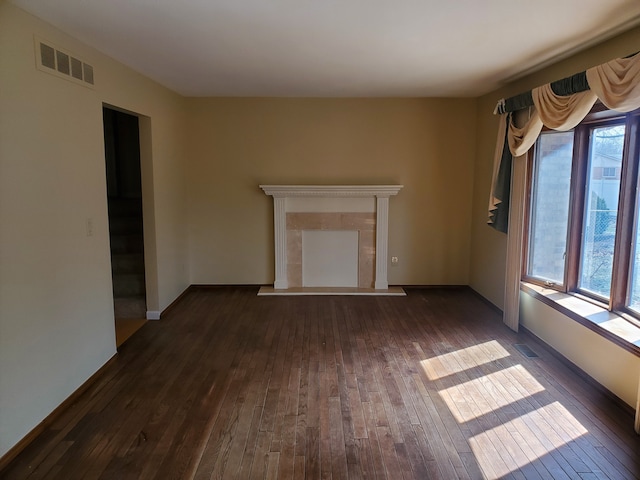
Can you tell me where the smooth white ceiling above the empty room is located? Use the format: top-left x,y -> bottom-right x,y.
12,0 -> 640,97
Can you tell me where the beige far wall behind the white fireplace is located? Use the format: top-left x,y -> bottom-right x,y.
188,98 -> 475,285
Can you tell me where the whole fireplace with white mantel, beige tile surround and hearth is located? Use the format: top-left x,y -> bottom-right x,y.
259,185 -> 404,295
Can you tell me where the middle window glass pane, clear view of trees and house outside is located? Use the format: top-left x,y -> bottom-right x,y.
579,125 -> 624,298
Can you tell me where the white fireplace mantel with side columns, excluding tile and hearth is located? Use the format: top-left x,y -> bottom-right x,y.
260,185 -> 403,290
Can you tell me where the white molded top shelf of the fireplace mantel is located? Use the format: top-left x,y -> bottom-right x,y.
260,185 -> 403,197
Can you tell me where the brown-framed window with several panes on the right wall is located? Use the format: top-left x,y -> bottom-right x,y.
523,106 -> 640,324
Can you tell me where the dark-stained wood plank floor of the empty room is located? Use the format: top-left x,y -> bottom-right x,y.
0,287 -> 640,480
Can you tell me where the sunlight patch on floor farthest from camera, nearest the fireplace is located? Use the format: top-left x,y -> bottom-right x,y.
420,340 -> 510,380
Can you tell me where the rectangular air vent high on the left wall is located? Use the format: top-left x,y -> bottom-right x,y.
35,37 -> 94,87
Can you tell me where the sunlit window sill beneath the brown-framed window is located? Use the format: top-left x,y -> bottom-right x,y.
520,282 -> 640,357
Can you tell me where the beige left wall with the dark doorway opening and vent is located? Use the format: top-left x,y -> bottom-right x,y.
0,2 -> 188,462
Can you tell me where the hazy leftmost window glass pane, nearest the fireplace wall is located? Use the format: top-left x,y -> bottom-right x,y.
527,132 -> 573,284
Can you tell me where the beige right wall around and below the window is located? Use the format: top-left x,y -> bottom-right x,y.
470,29 -> 640,406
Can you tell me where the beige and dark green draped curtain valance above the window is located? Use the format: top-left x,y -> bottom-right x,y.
488,54 -> 640,233
